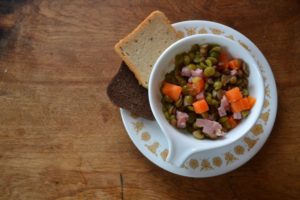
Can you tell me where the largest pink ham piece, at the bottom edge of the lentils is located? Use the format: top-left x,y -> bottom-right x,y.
195,119 -> 224,138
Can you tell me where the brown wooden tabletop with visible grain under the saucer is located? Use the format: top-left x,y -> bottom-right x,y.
0,0 -> 300,200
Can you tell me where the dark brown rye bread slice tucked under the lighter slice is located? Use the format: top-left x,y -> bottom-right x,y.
106,62 -> 154,120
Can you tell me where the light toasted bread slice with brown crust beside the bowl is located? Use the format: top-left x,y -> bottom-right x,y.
115,11 -> 178,88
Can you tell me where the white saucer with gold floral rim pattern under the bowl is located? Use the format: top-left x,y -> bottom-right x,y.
120,20 -> 277,177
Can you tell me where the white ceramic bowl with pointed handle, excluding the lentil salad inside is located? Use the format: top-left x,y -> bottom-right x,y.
148,34 -> 264,166
